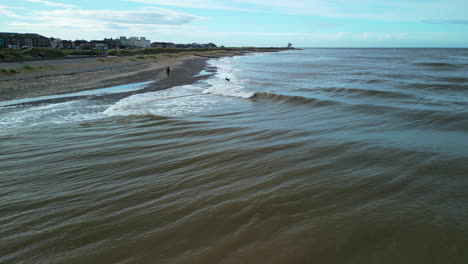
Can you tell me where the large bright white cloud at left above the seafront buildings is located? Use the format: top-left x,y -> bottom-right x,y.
8,8 -> 206,39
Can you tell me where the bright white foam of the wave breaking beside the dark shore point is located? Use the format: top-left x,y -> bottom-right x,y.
104,54 -> 255,117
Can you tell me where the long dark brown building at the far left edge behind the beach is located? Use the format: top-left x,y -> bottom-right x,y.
0,32 -> 51,48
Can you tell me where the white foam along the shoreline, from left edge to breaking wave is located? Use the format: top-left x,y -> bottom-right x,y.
0,58 -> 254,132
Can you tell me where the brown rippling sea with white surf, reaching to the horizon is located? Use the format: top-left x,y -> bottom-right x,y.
0,48 -> 468,264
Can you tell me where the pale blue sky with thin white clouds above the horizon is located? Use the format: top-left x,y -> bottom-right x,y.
0,0 -> 468,48
